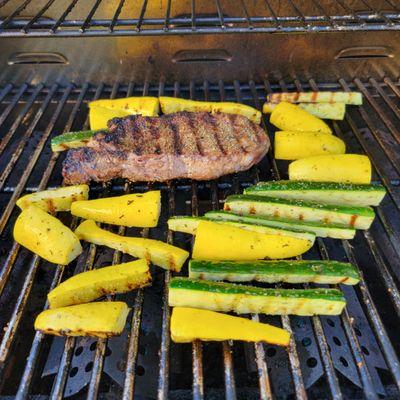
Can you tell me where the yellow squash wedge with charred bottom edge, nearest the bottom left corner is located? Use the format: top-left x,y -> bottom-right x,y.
35,301 -> 129,338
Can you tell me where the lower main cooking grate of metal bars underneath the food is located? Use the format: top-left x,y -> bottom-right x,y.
0,78 -> 400,399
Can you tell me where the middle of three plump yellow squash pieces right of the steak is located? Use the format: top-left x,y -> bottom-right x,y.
275,131 -> 346,160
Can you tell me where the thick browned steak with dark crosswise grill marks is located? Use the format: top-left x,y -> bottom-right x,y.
63,112 -> 269,184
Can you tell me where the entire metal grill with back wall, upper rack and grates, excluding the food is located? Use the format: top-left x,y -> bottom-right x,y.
0,0 -> 400,400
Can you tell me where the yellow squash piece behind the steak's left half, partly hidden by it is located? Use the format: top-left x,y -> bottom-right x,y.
89,97 -> 159,129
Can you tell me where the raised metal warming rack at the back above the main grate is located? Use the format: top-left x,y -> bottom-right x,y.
0,0 -> 400,37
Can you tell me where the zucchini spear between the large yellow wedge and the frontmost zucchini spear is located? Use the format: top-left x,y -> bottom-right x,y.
189,260 -> 360,285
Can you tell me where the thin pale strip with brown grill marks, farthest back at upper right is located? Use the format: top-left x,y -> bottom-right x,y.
267,92 -> 362,106
